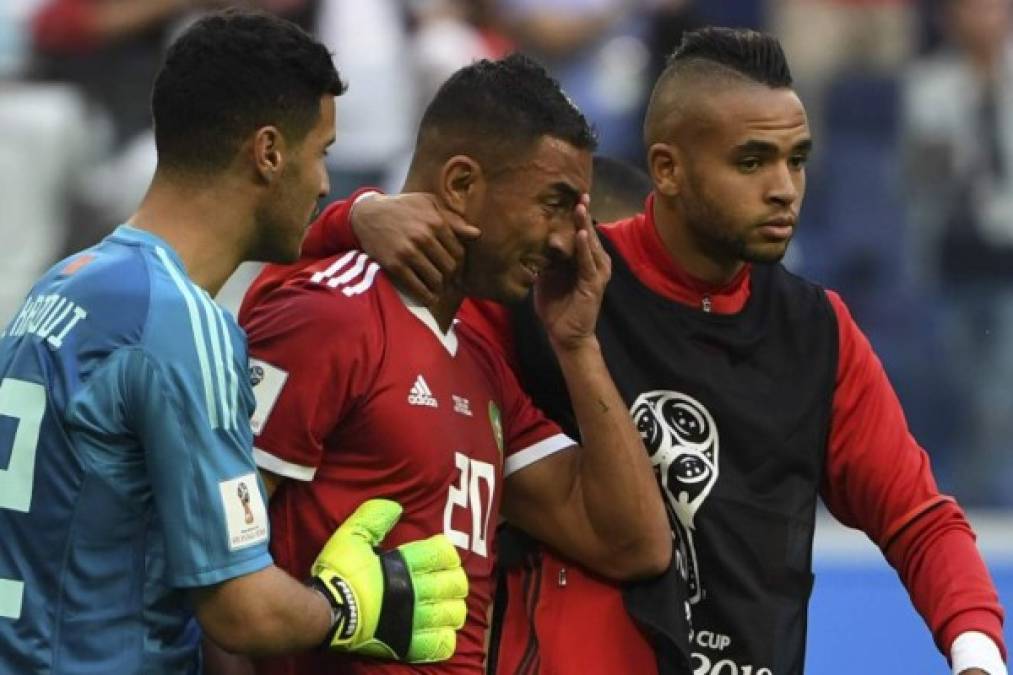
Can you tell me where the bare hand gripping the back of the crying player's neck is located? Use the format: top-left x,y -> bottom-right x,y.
350,193 -> 481,305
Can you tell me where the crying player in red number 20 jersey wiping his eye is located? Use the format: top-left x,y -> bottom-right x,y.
240,56 -> 672,675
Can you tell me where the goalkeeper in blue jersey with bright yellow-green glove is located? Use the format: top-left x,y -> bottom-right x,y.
0,11 -> 467,675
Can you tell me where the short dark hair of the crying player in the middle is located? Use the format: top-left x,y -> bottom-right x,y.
416,54 -> 598,167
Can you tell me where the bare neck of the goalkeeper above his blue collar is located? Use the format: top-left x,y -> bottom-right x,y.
130,168 -> 254,296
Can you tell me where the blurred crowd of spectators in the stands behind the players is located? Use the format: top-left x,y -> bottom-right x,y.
0,0 -> 1013,507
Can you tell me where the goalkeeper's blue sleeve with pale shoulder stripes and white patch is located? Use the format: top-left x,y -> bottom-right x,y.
127,255 -> 270,587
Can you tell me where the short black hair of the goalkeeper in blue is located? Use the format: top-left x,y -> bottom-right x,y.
151,9 -> 344,171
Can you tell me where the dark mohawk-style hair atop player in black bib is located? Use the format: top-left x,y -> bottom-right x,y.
666,26 -> 791,88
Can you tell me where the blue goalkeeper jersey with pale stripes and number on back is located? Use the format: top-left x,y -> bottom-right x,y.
0,225 -> 271,675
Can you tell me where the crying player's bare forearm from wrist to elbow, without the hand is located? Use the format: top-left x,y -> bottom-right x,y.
554,339 -> 672,571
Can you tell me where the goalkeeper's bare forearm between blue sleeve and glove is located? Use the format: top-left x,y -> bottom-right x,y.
196,567 -> 332,655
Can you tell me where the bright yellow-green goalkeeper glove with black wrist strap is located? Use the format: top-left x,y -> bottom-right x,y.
310,500 -> 468,663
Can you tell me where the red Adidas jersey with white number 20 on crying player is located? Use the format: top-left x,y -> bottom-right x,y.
243,251 -> 573,675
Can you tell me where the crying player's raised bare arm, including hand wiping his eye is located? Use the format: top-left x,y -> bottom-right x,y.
502,198 -> 672,579
